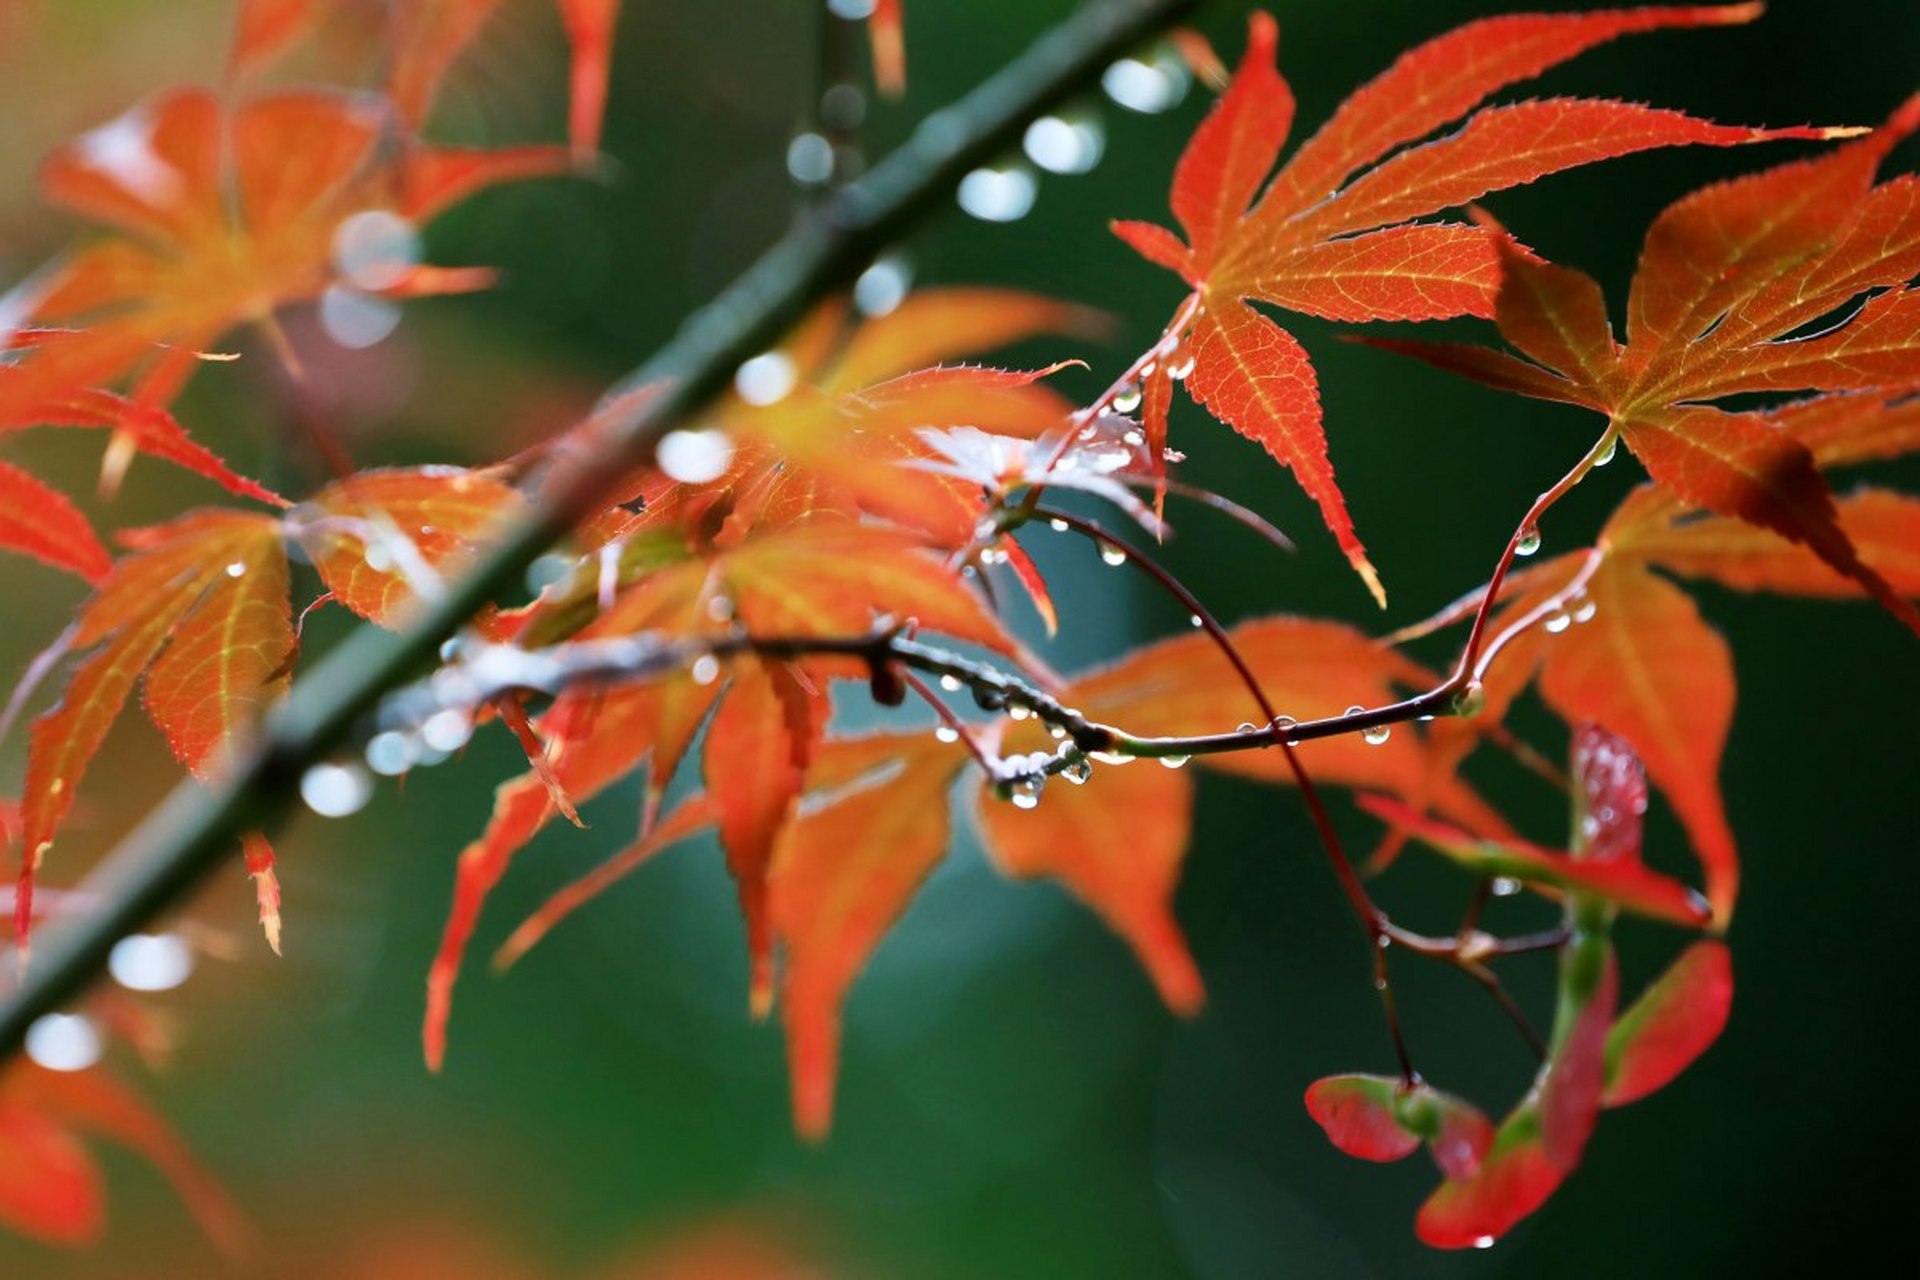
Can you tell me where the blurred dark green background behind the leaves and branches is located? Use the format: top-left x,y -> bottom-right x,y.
0,0 -> 1920,1280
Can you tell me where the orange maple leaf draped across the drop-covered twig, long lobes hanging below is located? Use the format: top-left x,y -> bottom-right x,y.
422,518 -> 1023,1067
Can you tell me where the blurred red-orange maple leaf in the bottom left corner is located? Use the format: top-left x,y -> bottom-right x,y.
0,1061 -> 248,1253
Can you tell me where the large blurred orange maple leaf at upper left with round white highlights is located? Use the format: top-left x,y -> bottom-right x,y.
11,88 -> 563,475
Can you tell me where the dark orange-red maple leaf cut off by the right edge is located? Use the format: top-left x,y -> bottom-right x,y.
1388,98 -> 1920,631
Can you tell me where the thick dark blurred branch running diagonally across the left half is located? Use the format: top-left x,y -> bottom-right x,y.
0,0 -> 1198,1061
